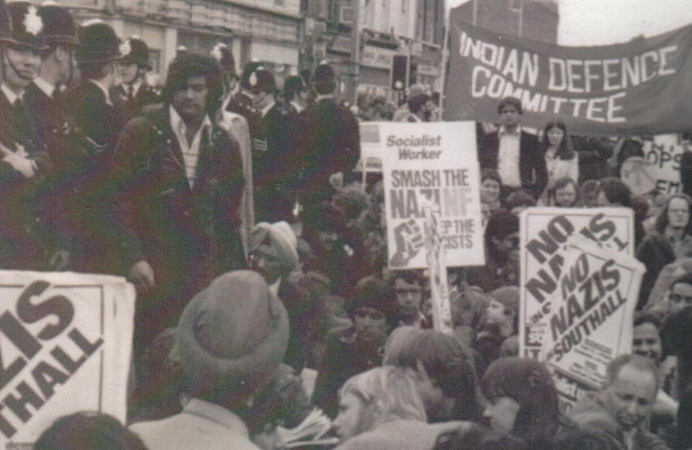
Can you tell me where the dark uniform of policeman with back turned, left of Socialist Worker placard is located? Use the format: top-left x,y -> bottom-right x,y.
301,99 -> 360,196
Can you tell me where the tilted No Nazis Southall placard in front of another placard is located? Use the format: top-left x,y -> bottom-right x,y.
539,238 -> 646,411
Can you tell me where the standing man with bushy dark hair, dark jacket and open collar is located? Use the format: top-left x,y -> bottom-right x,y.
113,52 -> 245,358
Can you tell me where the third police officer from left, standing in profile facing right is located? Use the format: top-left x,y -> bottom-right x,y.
62,20 -> 125,274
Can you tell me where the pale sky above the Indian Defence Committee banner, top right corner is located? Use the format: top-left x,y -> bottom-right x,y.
447,0 -> 692,46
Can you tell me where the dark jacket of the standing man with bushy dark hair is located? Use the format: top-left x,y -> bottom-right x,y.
112,107 -> 245,337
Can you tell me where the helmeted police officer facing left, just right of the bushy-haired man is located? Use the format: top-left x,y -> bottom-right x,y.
248,66 -> 300,222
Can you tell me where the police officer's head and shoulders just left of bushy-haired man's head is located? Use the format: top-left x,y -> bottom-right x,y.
111,36 -> 161,120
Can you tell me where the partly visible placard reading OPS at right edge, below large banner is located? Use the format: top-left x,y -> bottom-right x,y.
644,134 -> 692,194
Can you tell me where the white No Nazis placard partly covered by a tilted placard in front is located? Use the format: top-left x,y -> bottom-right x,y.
519,208 -> 636,358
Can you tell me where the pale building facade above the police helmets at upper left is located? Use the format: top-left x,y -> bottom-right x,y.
65,0 -> 304,85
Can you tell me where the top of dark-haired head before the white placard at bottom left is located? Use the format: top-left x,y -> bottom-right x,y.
33,412 -> 150,450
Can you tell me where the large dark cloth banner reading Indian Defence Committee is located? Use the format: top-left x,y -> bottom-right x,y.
444,8 -> 692,135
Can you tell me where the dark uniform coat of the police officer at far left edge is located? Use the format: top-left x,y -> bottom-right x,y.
0,89 -> 51,270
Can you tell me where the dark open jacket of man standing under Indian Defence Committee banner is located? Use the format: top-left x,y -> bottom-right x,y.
478,131 -> 548,198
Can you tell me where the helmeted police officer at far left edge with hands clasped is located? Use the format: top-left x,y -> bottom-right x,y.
0,2 -> 50,270
